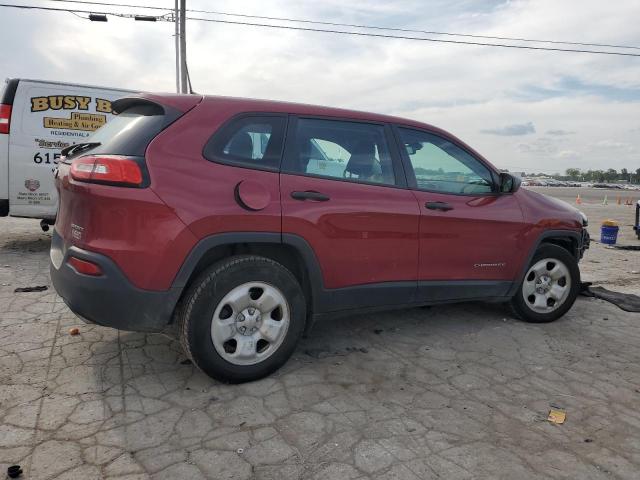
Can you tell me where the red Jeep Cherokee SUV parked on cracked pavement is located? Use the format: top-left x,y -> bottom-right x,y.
51,95 -> 588,382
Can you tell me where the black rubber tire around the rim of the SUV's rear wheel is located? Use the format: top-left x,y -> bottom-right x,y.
176,255 -> 306,383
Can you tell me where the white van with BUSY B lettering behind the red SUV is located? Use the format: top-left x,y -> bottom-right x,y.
0,78 -> 132,230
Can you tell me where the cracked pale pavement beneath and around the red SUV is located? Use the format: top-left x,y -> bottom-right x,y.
0,189 -> 640,480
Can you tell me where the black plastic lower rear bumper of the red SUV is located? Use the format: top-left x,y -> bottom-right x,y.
50,229 -> 182,332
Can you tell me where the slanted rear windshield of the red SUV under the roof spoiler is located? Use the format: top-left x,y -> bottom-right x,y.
68,103 -> 181,158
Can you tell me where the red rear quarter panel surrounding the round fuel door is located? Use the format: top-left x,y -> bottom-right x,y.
145,99 -> 281,239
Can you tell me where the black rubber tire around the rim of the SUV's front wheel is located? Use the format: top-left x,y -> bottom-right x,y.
509,244 -> 580,323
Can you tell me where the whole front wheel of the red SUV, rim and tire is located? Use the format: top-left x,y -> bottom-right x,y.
510,244 -> 580,323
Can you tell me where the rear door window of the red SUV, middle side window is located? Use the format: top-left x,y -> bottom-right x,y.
288,118 -> 395,185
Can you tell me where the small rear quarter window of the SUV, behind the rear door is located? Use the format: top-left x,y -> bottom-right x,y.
203,115 -> 286,170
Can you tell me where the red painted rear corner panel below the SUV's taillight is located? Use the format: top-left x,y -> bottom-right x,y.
55,164 -> 197,290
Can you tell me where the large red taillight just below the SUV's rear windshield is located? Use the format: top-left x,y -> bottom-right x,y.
70,155 -> 144,187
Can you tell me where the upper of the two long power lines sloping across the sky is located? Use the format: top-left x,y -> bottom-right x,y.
47,0 -> 640,50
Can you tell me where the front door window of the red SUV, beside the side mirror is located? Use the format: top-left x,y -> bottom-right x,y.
399,128 -> 493,195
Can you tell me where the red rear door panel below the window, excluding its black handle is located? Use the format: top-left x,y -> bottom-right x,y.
281,174 -> 420,288
